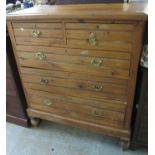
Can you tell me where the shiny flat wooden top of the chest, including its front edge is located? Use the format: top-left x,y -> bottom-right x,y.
7,3 -> 147,21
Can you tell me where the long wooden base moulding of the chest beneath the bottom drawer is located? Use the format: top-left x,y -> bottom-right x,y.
27,108 -> 130,139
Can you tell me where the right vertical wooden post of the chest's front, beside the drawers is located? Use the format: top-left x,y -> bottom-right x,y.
124,23 -> 144,128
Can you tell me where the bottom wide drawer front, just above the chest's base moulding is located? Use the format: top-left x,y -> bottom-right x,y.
29,90 -> 124,127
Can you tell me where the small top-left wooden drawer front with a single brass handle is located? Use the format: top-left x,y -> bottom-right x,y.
13,23 -> 64,45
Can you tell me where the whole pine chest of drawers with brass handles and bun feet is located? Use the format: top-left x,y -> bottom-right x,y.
7,3 -> 147,147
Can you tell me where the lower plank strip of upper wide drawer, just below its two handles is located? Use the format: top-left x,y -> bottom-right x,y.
19,59 -> 129,79
